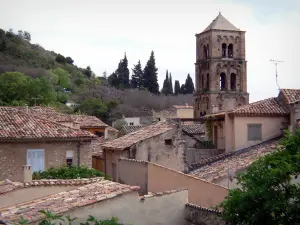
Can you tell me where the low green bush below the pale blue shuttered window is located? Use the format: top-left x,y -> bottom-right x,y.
32,166 -> 104,180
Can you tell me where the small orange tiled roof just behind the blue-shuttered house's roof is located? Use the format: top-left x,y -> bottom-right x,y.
72,115 -> 108,128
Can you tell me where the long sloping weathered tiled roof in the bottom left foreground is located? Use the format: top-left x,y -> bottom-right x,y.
0,180 -> 139,223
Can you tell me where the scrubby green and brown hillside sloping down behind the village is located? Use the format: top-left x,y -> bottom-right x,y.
0,29 -> 193,123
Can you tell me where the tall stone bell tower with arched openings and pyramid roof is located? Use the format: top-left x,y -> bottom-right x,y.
194,13 -> 249,118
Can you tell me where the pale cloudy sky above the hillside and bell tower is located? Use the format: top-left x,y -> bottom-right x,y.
0,0 -> 300,102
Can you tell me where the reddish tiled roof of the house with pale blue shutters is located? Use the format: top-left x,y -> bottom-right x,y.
0,107 -> 95,141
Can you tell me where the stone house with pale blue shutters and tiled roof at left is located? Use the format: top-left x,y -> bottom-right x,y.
0,107 -> 95,180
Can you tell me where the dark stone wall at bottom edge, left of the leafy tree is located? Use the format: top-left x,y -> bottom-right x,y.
184,203 -> 225,225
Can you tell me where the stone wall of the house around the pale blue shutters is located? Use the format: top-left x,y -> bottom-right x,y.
0,142 -> 92,181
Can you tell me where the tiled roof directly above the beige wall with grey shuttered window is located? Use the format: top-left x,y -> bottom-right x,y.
230,98 -> 289,116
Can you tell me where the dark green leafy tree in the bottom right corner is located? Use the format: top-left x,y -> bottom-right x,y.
219,129 -> 300,225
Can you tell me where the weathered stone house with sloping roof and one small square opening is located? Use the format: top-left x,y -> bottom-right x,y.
102,122 -> 187,181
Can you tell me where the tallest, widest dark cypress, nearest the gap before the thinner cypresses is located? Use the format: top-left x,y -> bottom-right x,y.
143,51 -> 159,94
